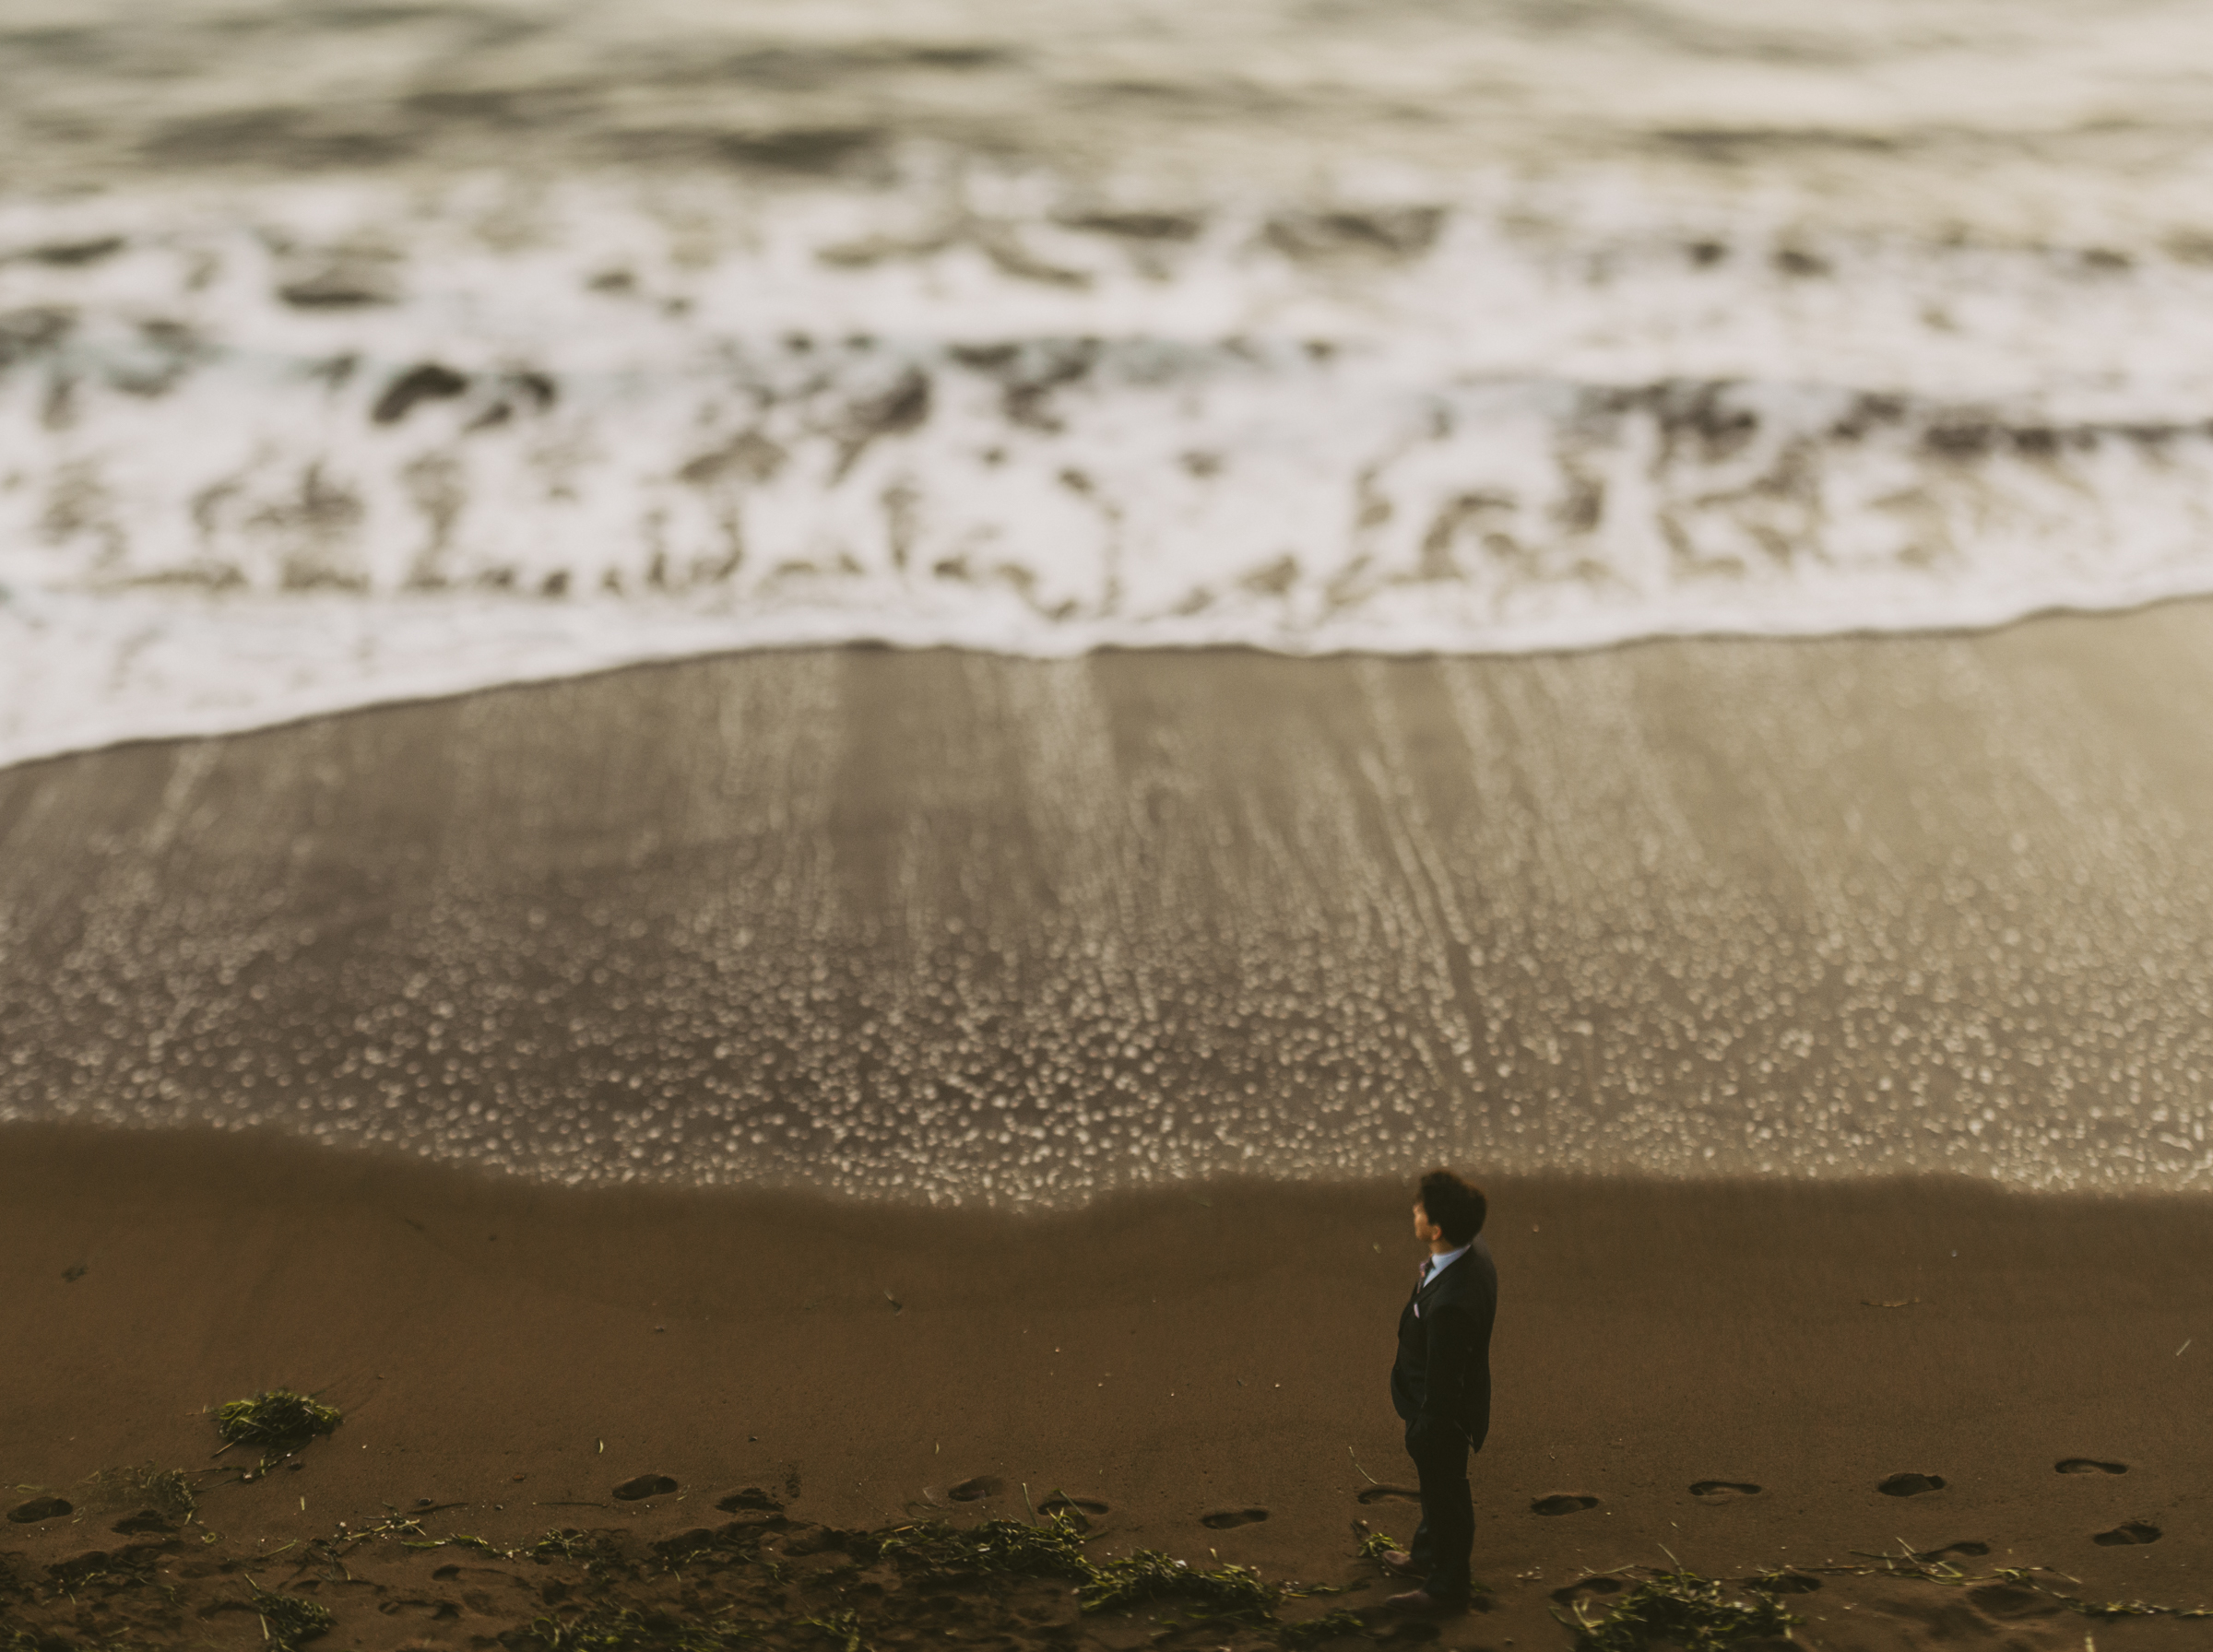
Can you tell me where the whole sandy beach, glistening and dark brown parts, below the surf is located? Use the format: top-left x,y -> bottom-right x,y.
13,606 -> 2213,1652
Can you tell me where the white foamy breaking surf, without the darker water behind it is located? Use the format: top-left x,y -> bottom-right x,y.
0,164 -> 2213,761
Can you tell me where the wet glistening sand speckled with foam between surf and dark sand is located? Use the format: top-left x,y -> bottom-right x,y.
0,604 -> 2213,1203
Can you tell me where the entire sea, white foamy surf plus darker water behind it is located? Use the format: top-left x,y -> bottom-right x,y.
0,0 -> 2213,761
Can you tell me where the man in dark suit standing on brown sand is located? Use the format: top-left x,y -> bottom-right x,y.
1383,1170 -> 1498,1612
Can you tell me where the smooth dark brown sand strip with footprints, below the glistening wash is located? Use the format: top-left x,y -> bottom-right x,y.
0,1126 -> 2213,1647
